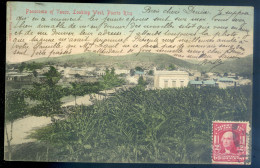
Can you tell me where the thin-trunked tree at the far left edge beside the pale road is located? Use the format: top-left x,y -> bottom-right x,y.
5,90 -> 28,161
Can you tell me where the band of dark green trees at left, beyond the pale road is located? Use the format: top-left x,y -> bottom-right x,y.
5,66 -> 124,160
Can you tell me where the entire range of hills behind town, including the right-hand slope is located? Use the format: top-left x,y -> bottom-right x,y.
24,52 -> 253,75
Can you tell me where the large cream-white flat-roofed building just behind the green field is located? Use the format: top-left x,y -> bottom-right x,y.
154,68 -> 189,89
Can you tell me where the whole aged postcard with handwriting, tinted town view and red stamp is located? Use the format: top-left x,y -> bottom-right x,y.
5,2 -> 254,164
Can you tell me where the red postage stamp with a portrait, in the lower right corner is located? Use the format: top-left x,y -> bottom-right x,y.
212,121 -> 250,164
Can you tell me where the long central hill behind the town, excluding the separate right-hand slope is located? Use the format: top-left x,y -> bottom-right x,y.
28,52 -> 198,69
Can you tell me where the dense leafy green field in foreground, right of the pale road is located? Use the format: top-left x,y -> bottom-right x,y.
29,87 -> 251,163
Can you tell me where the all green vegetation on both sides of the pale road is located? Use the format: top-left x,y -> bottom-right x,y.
6,62 -> 252,163
